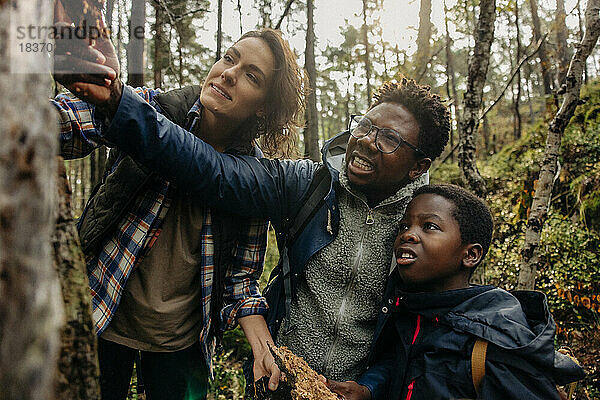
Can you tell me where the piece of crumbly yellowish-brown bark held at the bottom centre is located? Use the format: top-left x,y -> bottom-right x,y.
269,346 -> 340,400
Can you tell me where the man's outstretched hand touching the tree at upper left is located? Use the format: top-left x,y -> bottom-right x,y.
54,0 -> 123,117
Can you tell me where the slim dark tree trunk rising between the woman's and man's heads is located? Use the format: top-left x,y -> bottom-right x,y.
304,0 -> 320,162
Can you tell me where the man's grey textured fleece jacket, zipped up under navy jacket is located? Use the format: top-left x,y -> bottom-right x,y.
277,163 -> 428,381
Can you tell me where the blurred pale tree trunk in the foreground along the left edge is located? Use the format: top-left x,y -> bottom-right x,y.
0,0 -> 63,400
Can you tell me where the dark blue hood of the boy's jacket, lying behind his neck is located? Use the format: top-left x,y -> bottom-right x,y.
403,286 -> 585,384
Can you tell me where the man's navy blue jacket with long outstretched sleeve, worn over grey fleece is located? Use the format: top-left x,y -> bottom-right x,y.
99,83 -> 382,390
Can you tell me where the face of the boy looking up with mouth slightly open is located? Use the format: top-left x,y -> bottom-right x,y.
394,193 -> 481,292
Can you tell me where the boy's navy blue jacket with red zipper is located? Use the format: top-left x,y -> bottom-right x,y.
363,271 -> 584,400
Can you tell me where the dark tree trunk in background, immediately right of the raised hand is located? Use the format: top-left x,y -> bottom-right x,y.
127,0 -> 146,87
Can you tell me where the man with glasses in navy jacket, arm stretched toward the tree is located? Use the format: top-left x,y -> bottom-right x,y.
76,78 -> 450,399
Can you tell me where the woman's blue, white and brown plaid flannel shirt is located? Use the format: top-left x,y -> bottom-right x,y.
51,88 -> 268,371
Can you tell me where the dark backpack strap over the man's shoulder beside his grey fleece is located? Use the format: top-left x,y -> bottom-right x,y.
281,165 -> 331,334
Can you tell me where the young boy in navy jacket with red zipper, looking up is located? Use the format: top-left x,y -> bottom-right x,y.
354,185 -> 584,400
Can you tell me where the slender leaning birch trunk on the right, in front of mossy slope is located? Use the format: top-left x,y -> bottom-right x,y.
517,0 -> 600,289
